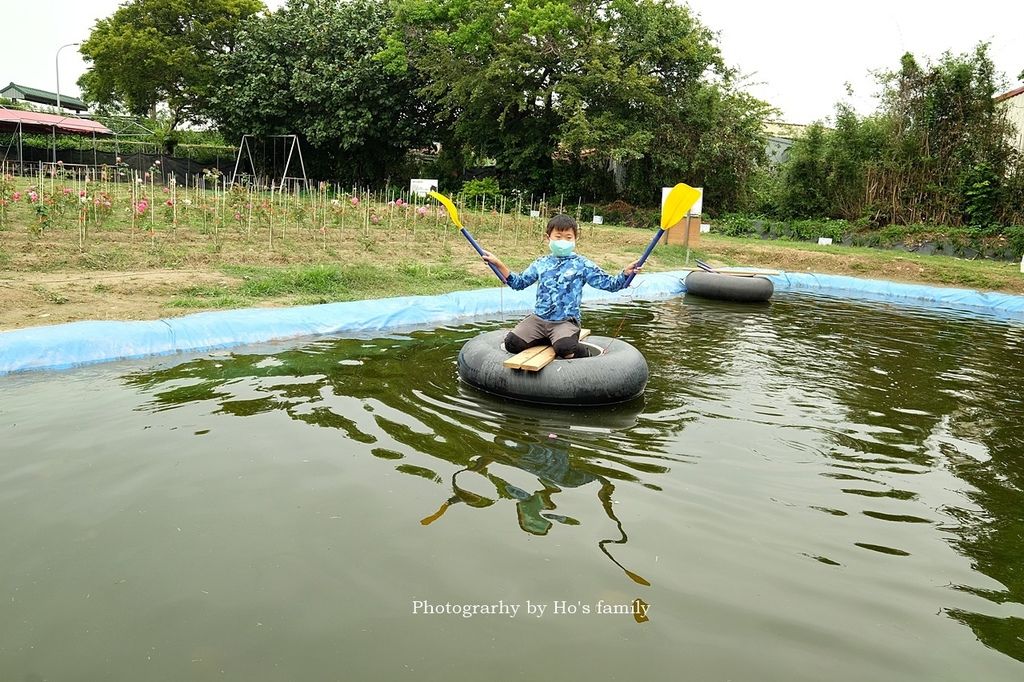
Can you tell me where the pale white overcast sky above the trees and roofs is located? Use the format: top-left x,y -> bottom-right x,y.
0,0 -> 1024,124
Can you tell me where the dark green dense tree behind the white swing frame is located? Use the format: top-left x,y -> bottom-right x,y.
209,0 -> 429,181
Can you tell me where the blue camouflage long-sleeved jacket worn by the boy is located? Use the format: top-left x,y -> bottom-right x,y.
508,254 -> 626,324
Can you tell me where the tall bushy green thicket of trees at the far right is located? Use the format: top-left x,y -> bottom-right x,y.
779,44 -> 1024,229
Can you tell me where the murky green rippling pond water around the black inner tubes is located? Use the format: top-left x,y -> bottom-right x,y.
0,296 -> 1024,682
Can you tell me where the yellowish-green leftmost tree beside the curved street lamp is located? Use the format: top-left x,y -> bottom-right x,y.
78,0 -> 265,131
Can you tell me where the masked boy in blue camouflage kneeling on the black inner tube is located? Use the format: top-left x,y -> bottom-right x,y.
483,215 -> 640,358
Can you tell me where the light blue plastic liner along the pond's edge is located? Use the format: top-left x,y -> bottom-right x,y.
0,270 -> 1024,375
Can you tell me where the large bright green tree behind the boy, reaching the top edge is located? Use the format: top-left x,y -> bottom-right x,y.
389,0 -> 768,203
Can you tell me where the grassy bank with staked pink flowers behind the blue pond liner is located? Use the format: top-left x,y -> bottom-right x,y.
0,169 -> 1024,329
